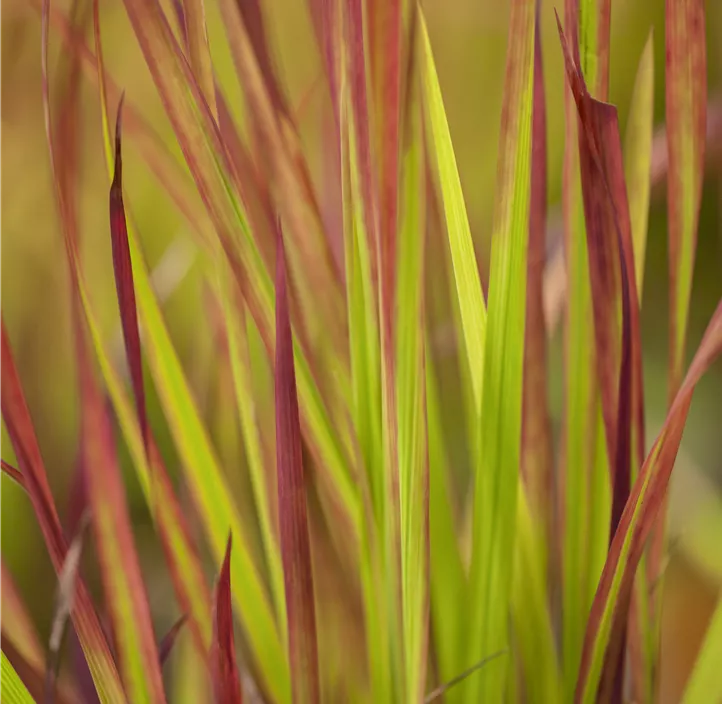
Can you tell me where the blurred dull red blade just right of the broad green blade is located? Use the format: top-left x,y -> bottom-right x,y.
521,3 -> 554,548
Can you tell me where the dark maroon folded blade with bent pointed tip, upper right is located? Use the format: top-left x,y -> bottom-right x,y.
557,12 -> 644,699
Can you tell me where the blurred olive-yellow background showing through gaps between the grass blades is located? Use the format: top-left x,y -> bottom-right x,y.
0,0 -> 722,702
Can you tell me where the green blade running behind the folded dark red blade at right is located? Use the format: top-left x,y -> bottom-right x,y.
561,0 -> 611,701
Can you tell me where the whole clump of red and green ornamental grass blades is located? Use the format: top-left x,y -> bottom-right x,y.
0,0 -> 722,704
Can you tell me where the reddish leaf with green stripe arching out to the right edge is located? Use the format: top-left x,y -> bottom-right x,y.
575,301 -> 722,704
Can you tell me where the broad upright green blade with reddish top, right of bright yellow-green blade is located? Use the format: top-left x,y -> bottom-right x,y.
462,0 -> 536,701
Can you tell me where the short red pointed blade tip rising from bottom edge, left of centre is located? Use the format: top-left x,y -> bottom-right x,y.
210,535 -> 243,704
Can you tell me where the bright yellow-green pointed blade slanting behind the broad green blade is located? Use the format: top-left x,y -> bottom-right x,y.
419,11 -> 486,412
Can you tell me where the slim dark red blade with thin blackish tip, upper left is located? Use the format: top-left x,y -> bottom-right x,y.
109,96 -> 149,455
